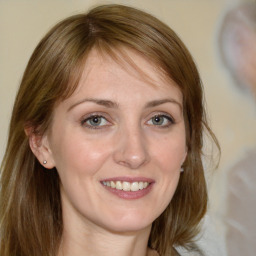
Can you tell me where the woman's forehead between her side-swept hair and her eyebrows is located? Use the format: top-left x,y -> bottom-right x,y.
72,47 -> 180,97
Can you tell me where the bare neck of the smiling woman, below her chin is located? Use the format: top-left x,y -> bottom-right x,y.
58,218 -> 151,256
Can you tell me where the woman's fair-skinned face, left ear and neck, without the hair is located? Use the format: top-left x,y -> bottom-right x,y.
30,50 -> 187,256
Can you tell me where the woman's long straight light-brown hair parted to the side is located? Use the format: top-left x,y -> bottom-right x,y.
0,5 -> 220,256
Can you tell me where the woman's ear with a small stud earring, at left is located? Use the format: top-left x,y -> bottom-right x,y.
25,127 -> 55,169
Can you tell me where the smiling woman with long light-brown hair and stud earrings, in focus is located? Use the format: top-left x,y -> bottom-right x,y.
0,5 -> 219,256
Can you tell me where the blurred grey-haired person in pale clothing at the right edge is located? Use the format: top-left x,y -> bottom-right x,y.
219,2 -> 256,256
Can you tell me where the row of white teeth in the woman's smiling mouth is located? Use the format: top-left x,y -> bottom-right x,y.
102,180 -> 149,192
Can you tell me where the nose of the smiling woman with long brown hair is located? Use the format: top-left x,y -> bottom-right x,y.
113,128 -> 150,169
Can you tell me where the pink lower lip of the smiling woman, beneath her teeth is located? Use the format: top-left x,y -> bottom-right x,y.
102,182 -> 153,200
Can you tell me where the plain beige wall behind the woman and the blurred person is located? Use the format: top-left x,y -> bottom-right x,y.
0,0 -> 256,256
